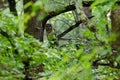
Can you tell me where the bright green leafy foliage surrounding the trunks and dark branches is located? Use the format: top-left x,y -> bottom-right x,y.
0,0 -> 120,80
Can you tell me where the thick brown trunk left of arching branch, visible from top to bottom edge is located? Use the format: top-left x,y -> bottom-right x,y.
23,0 -> 44,80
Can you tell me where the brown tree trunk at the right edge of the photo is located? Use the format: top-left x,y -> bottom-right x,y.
111,6 -> 120,56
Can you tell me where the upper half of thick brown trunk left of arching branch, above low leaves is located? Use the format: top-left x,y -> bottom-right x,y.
24,0 -> 44,41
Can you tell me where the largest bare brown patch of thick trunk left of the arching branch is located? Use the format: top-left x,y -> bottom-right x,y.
25,12 -> 44,41
